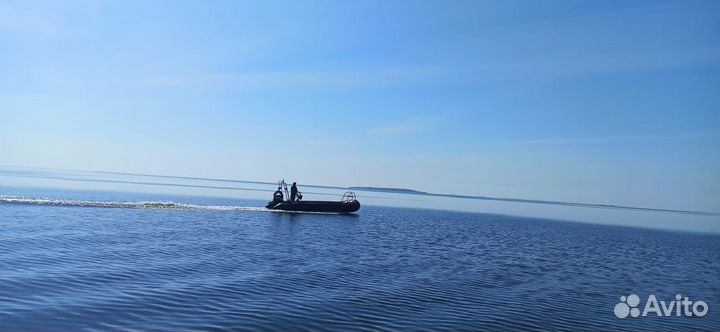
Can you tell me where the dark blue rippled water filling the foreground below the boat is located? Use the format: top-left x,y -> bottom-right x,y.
0,190 -> 720,331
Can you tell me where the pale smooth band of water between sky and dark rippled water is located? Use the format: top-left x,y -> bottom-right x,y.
0,167 -> 720,233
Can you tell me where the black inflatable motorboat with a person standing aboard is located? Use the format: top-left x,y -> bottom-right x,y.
265,180 -> 360,213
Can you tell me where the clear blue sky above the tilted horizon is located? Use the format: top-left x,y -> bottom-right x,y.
0,0 -> 720,211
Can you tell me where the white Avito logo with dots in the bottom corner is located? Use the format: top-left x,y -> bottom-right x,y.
613,294 -> 709,318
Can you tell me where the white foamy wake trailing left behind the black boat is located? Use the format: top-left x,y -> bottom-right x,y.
0,195 -> 273,212
